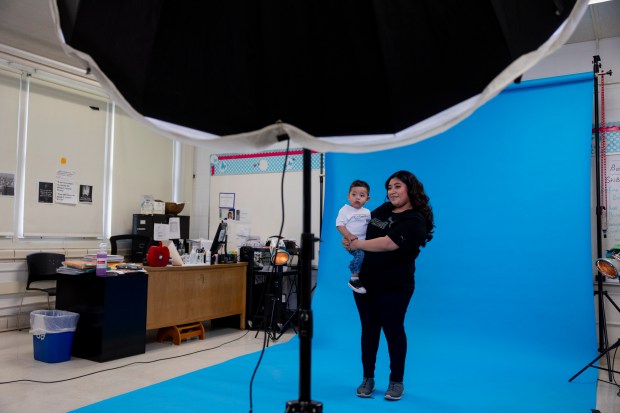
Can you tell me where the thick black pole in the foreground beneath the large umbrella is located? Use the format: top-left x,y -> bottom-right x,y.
286,148 -> 323,413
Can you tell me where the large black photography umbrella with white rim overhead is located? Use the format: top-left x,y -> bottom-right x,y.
50,0 -> 587,152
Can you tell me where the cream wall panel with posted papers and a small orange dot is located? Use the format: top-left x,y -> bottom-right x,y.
23,79 -> 107,237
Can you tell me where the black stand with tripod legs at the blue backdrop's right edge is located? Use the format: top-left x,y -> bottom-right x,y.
568,55 -> 620,382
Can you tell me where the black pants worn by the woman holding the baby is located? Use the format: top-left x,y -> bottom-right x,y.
353,288 -> 413,382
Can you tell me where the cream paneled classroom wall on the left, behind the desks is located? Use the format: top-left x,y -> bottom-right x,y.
0,64 -> 194,331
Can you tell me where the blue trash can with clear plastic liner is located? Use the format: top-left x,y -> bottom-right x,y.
30,310 -> 80,363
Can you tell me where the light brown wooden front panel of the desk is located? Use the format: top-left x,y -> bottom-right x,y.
145,262 -> 247,330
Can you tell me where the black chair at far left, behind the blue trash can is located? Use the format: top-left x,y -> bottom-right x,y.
17,252 -> 65,327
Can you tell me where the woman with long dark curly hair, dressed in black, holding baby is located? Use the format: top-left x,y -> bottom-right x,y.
342,171 -> 435,400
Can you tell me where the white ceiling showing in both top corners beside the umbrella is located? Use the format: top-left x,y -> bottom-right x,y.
0,0 -> 620,77
